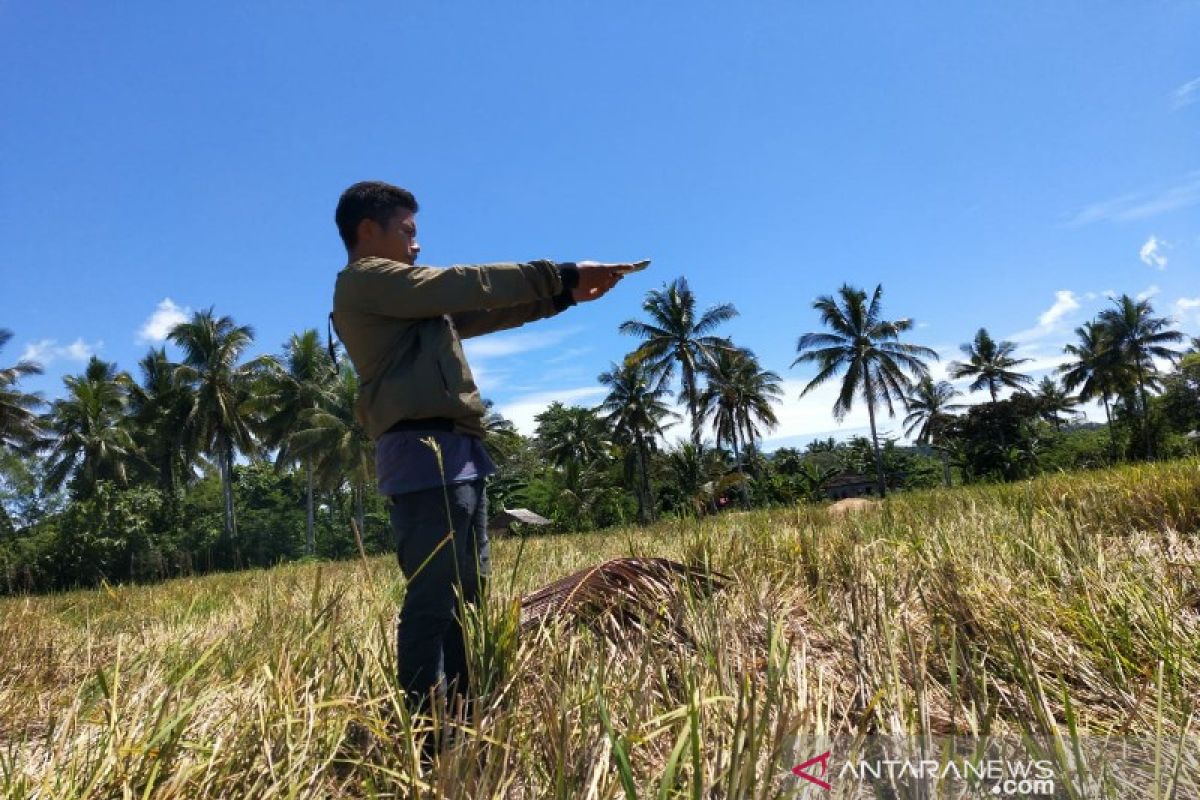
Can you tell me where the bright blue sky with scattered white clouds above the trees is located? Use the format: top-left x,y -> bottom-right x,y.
0,0 -> 1200,447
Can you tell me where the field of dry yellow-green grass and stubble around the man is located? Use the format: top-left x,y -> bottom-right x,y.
0,459 -> 1200,798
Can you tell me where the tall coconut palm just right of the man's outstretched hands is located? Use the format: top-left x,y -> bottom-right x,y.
620,277 -> 738,445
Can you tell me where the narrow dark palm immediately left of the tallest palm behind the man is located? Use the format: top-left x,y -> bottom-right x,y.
128,348 -> 197,503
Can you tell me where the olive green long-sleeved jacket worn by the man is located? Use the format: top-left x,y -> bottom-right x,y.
332,258 -> 577,439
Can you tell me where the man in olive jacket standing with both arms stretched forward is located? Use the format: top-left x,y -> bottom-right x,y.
332,181 -> 631,712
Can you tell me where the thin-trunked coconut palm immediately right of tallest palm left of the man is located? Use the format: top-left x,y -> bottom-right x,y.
248,329 -> 335,555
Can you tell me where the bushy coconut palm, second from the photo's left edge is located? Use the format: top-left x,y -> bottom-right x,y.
46,356 -> 146,497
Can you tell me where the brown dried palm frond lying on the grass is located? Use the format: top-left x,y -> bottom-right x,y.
521,558 -> 728,643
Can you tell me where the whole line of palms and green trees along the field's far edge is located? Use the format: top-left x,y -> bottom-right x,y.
0,278 -> 1200,591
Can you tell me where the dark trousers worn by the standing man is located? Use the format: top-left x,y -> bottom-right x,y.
391,479 -> 490,712
